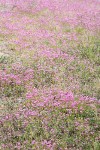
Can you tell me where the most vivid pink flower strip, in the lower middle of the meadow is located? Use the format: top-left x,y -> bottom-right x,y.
26,90 -> 96,110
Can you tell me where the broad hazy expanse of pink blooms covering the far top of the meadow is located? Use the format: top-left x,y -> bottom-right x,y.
0,0 -> 100,53
